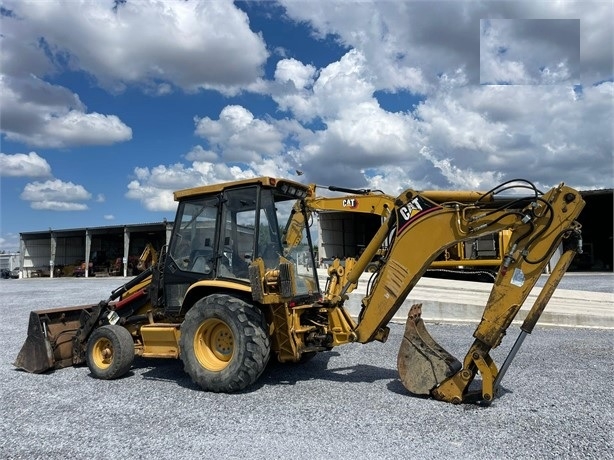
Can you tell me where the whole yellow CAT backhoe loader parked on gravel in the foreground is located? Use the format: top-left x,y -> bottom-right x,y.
15,177 -> 584,403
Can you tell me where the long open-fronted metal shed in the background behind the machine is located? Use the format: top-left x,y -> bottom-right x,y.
12,189 -> 614,278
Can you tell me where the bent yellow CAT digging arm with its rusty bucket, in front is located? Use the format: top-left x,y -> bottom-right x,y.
344,184 -> 584,402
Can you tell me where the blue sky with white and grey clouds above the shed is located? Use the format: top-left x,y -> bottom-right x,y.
0,0 -> 614,251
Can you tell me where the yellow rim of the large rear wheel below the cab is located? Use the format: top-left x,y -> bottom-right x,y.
194,318 -> 235,371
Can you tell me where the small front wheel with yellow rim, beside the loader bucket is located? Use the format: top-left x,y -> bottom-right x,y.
86,324 -> 134,380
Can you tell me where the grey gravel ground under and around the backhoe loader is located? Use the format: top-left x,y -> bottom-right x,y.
0,279 -> 614,460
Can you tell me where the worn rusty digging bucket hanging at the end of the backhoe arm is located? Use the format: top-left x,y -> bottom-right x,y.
397,304 -> 462,395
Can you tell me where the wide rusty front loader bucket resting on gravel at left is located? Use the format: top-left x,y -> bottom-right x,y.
13,305 -> 94,374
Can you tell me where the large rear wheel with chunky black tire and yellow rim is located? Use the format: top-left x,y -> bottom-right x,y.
179,294 -> 271,393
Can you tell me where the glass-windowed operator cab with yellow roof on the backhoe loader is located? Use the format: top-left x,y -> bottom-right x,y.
163,178 -> 320,310
